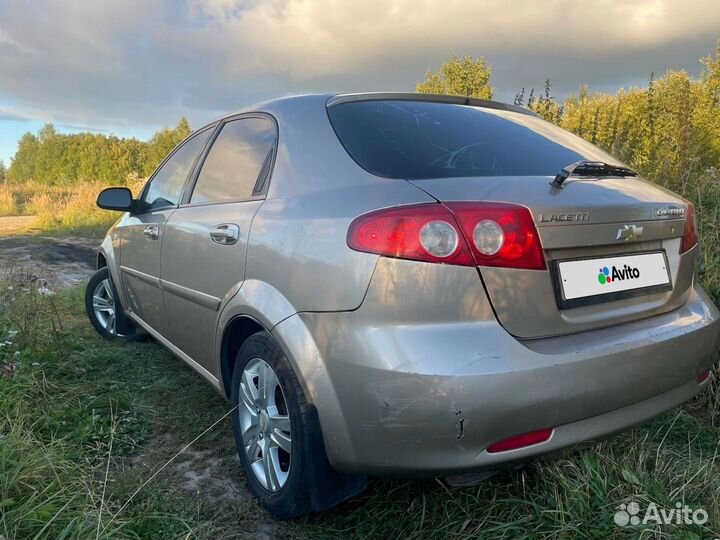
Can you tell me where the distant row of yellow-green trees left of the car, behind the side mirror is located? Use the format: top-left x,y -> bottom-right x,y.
0,118 -> 191,185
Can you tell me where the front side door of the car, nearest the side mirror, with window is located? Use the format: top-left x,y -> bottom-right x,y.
119,127 -> 213,337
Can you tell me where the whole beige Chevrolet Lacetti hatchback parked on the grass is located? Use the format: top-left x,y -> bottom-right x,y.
87,94 -> 720,517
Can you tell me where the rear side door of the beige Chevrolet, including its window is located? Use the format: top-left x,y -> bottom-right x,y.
161,115 -> 277,377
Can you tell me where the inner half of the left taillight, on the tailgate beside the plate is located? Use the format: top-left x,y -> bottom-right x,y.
446,202 -> 547,270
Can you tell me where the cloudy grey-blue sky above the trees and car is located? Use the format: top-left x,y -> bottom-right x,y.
0,0 -> 720,164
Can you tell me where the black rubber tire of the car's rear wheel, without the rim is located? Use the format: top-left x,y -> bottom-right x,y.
231,332 -> 314,519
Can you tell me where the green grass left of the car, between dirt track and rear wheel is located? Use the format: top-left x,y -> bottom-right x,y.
0,277 -> 282,540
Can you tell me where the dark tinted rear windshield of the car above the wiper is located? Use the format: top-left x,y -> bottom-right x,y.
328,100 -> 620,179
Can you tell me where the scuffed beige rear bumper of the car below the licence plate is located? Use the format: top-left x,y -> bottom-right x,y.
273,265 -> 720,476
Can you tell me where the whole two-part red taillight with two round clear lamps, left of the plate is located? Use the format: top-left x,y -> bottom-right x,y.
347,202 -> 546,270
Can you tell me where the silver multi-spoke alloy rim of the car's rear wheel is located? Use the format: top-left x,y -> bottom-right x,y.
238,358 -> 292,492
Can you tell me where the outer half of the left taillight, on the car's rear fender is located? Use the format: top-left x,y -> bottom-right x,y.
347,204 -> 475,266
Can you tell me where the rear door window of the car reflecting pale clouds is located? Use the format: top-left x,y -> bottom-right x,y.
190,117 -> 276,204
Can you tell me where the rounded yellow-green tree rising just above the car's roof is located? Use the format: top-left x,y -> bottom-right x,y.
415,56 -> 493,99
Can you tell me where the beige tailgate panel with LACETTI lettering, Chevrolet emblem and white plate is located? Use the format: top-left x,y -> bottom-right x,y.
411,176 -> 698,338
